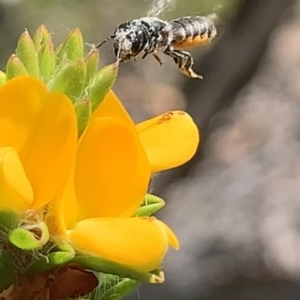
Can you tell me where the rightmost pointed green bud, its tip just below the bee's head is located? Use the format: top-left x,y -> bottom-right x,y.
88,62 -> 119,112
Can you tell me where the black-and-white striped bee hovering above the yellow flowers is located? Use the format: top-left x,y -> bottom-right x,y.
96,16 -> 217,79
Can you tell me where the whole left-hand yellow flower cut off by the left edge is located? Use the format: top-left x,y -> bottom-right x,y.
0,77 -> 77,213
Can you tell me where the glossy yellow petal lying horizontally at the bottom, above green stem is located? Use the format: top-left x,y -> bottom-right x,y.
69,217 -> 176,271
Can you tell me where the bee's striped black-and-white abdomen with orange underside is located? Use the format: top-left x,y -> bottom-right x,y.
170,16 -> 217,49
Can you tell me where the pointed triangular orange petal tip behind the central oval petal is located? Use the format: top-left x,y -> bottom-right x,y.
93,90 -> 134,126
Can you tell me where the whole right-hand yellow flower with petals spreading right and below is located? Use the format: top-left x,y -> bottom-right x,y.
56,92 -> 199,271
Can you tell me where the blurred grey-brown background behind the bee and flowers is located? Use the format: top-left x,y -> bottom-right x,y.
0,0 -> 300,300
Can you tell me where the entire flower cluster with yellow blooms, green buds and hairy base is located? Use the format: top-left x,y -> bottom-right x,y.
0,26 -> 199,300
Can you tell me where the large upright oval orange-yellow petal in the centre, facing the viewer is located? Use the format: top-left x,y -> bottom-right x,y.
75,117 -> 150,219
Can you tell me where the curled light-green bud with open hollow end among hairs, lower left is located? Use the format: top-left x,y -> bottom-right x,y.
8,222 -> 49,251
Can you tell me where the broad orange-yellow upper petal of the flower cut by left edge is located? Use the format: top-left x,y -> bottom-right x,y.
0,77 -> 77,208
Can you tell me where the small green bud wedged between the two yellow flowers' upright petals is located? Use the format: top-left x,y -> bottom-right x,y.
74,98 -> 92,137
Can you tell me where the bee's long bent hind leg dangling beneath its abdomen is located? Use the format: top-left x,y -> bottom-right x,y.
164,49 -> 203,79
